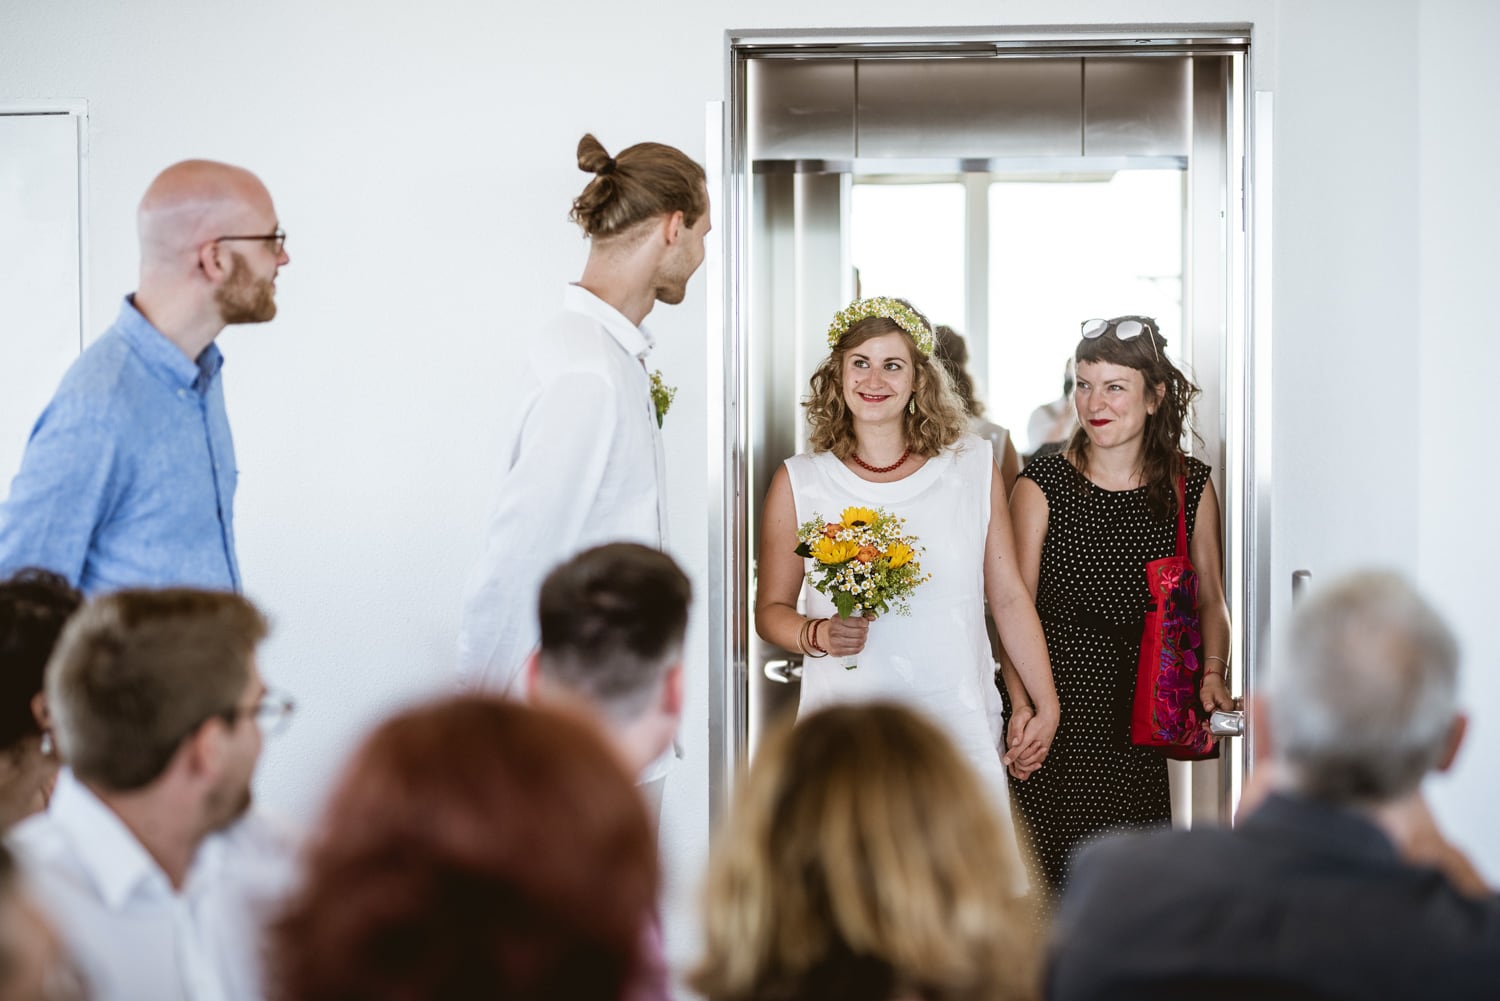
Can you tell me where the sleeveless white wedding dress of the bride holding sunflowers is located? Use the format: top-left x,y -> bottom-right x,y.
786,434 -> 1025,881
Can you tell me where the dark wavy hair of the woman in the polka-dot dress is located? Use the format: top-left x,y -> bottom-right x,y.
1067,315 -> 1199,521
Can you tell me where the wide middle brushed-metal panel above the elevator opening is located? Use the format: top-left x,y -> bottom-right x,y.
858,59 -> 1083,159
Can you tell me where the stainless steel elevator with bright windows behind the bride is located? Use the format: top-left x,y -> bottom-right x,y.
726,37 -> 1244,821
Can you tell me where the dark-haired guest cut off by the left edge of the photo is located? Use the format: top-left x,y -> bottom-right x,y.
0,569 -> 83,831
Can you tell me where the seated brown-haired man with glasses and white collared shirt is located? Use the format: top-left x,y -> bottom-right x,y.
12,588 -> 296,1001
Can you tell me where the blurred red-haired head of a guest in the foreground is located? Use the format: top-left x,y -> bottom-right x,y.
272,695 -> 657,1001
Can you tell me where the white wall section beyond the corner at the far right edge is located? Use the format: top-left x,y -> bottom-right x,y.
1416,0 -> 1500,878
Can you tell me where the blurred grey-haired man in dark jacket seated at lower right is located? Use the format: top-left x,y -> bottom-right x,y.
1047,573 -> 1500,1001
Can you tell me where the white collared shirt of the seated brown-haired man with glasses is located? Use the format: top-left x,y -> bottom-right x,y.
11,770 -> 296,1001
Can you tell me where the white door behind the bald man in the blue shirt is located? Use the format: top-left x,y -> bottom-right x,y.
0,110 -> 84,495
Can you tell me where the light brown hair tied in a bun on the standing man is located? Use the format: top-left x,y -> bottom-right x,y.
569,135 -> 708,240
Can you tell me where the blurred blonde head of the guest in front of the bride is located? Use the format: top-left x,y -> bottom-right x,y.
692,702 -> 1037,1001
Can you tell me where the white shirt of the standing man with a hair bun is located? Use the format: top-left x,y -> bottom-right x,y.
459,285 -> 666,698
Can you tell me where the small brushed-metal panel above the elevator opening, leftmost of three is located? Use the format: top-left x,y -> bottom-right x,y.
747,59 -> 855,161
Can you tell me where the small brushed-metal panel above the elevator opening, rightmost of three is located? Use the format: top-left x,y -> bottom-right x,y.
1083,57 -> 1193,156
